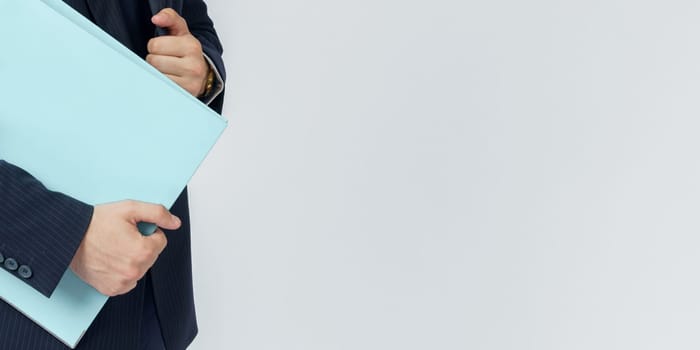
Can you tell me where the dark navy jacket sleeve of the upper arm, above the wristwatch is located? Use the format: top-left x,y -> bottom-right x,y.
181,0 -> 226,113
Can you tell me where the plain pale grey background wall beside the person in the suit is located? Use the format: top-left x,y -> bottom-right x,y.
191,0 -> 700,350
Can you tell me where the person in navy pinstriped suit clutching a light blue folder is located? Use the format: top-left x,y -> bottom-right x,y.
0,0 -> 225,350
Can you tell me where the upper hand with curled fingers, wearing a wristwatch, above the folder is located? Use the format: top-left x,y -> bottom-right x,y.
146,8 -> 210,97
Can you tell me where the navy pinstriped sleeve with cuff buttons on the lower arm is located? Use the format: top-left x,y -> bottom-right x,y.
0,159 -> 93,297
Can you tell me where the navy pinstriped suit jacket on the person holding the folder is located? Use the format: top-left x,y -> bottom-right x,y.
0,0 -> 225,350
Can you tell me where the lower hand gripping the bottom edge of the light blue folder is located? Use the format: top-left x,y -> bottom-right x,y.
70,201 -> 181,296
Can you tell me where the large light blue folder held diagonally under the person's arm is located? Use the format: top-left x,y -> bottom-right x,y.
0,0 -> 226,348
